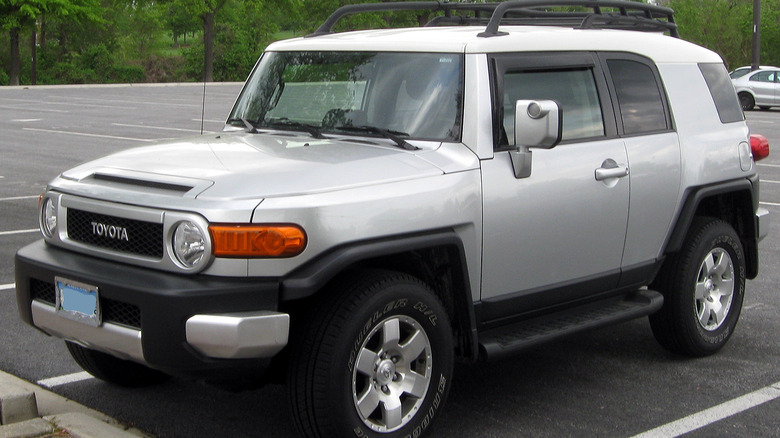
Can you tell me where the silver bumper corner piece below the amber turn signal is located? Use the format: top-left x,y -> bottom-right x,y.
186,311 -> 290,359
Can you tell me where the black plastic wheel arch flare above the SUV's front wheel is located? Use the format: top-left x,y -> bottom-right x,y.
280,230 -> 479,360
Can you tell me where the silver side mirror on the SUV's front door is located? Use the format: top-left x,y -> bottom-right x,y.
510,100 -> 563,179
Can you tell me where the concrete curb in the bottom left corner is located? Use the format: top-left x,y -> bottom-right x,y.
0,371 -> 152,438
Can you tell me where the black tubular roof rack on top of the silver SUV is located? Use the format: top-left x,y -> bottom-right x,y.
306,0 -> 680,38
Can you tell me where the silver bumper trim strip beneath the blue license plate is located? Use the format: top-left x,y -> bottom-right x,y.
32,300 -> 145,363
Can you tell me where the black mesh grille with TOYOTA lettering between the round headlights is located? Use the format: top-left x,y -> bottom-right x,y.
68,208 -> 163,258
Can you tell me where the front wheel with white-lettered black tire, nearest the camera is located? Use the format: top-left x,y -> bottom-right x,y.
287,270 -> 453,438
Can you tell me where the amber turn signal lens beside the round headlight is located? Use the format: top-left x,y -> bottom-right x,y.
209,224 -> 306,258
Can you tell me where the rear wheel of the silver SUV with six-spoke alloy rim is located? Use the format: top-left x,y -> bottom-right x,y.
650,218 -> 746,357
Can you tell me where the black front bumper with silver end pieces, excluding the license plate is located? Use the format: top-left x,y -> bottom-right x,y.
16,241 -> 289,377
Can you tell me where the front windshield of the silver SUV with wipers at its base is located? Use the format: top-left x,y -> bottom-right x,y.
228,52 -> 463,141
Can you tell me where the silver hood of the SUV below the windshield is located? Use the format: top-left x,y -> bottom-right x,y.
62,132 -> 443,200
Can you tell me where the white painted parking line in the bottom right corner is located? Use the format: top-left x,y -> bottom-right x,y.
632,382 -> 780,438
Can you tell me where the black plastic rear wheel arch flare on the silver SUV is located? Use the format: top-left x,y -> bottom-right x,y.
664,178 -> 758,279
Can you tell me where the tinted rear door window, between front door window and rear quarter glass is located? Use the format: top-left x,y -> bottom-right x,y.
607,59 -> 669,135
